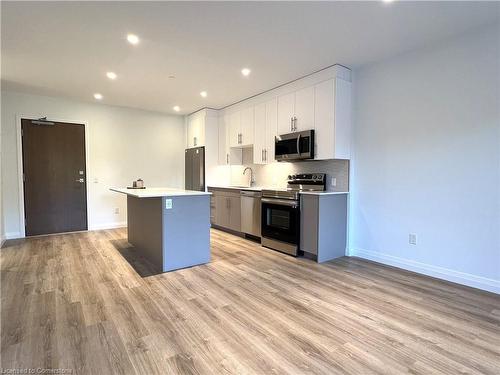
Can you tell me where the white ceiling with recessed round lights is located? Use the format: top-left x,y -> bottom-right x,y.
1,1 -> 500,113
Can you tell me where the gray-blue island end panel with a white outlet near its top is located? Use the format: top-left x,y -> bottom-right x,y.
162,195 -> 210,272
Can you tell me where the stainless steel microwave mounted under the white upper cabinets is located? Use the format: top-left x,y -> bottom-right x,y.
274,130 -> 314,161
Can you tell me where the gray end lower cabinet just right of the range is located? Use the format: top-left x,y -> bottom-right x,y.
300,194 -> 347,263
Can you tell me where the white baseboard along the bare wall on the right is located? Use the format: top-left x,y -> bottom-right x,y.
349,249 -> 500,294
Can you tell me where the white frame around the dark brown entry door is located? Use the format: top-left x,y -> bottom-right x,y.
16,113 -> 91,238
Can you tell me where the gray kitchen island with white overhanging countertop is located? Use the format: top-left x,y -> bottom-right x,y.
110,188 -> 210,272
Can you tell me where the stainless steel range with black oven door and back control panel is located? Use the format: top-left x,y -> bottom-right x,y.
261,173 -> 326,256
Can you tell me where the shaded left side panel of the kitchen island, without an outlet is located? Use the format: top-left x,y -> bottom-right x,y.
127,195 -> 163,267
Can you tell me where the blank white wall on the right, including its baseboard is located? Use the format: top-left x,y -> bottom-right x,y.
350,25 -> 500,293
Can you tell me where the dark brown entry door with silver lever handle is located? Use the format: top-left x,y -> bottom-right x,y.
22,119 -> 87,236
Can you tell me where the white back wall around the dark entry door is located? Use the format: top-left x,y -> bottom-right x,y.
1,92 -> 185,237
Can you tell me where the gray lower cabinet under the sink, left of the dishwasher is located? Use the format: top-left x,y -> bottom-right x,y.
208,188 -> 241,232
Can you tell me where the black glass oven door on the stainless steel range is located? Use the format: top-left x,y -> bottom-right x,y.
261,198 -> 300,245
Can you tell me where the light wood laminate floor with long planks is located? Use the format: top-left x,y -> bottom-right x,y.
0,229 -> 500,375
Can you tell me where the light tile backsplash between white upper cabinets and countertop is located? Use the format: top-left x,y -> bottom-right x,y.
229,149 -> 349,191
